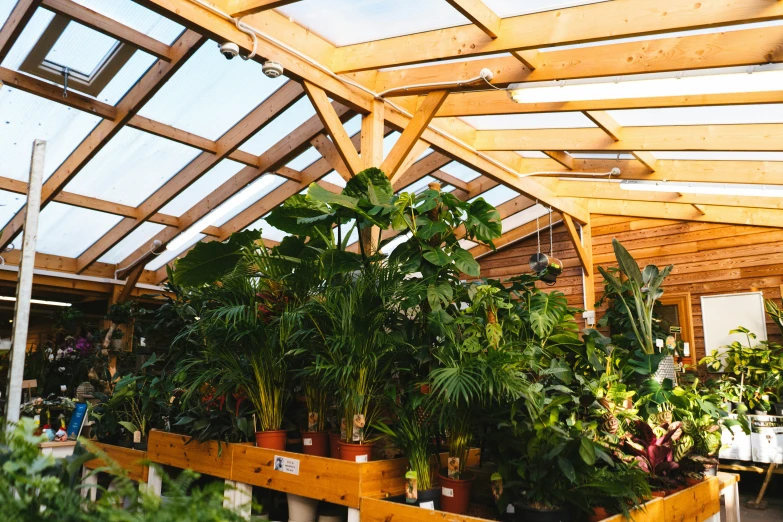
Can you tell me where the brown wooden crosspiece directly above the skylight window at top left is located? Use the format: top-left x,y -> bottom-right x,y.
41,0 -> 171,61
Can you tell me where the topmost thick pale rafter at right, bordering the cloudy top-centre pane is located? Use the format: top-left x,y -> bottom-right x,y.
332,0 -> 783,72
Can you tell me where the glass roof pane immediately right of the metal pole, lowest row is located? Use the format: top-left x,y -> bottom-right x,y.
36,202 -> 122,257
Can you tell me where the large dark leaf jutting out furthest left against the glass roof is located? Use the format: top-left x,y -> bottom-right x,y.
173,230 -> 261,287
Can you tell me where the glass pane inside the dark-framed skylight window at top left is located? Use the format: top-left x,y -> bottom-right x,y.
46,21 -> 119,76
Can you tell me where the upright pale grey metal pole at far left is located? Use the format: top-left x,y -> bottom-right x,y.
6,140 -> 46,425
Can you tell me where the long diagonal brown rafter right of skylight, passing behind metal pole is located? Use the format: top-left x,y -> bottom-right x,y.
0,31 -> 206,249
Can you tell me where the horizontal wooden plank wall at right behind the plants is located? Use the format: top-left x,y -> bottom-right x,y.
479,215 -> 783,358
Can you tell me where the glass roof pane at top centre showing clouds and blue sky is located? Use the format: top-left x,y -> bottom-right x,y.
278,0 -> 470,46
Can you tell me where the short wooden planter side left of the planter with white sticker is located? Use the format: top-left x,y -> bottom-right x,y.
147,431 -> 232,479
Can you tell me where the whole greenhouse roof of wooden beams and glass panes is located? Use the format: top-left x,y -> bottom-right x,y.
0,0 -> 783,294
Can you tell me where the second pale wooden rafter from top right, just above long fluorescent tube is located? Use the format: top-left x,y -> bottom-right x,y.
375,24 -> 783,93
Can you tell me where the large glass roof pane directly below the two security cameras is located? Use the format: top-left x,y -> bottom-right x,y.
139,41 -> 285,140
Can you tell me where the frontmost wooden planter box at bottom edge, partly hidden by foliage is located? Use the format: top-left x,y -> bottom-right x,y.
361,477 -> 720,522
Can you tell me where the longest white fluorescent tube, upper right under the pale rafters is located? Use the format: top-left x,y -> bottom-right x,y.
508,70 -> 783,103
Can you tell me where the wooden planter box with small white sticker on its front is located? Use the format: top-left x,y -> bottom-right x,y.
229,445 -> 408,508
